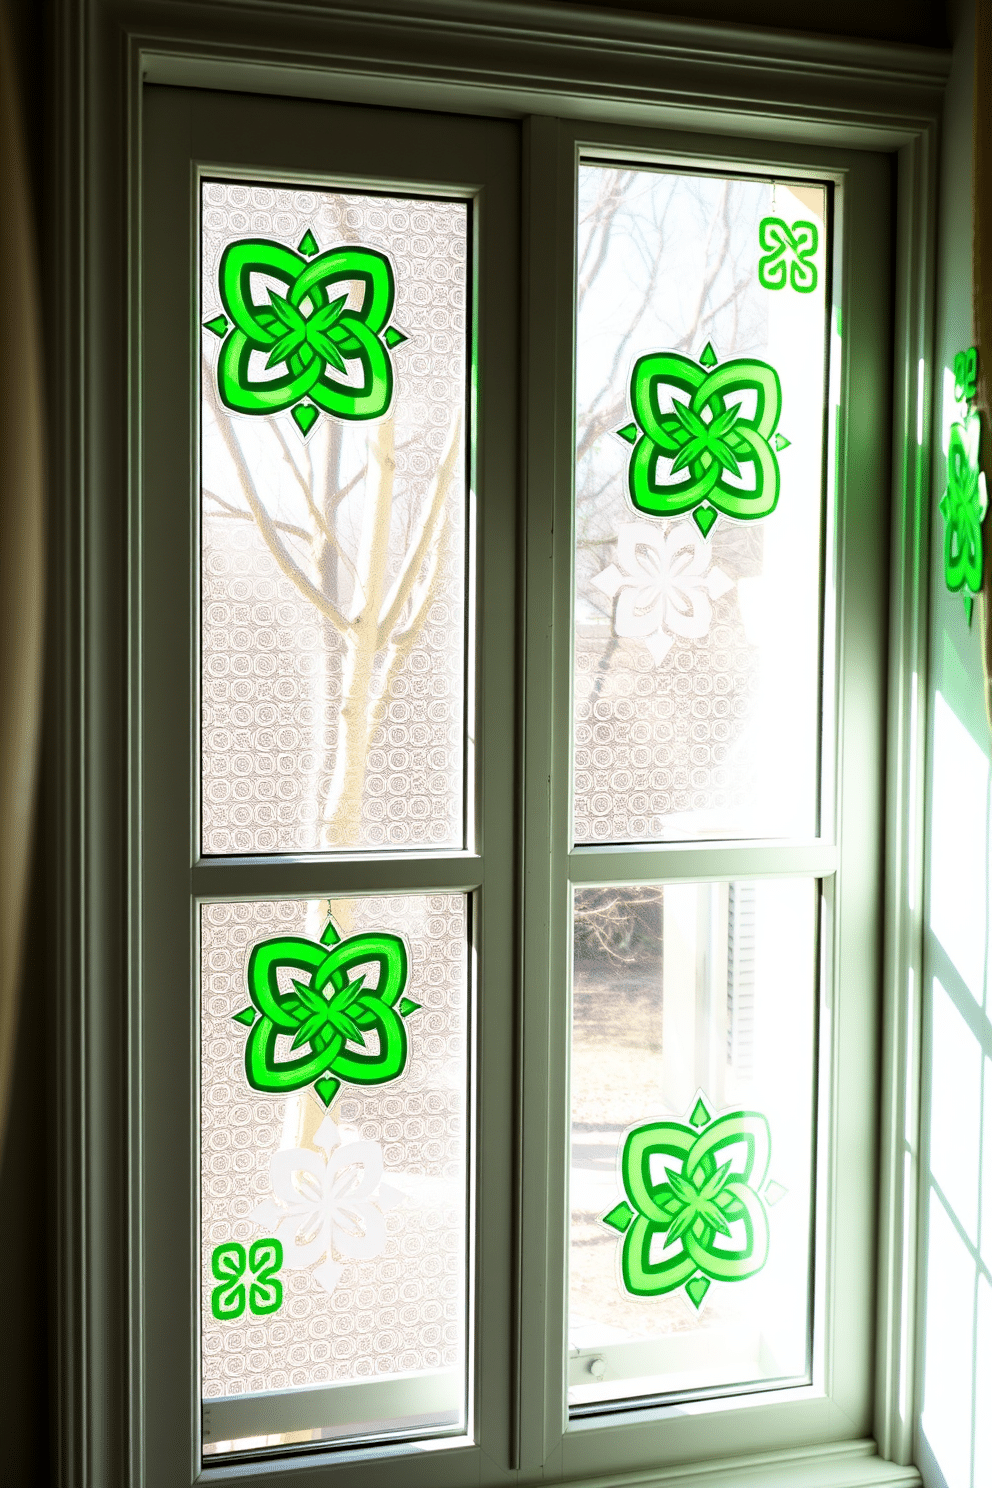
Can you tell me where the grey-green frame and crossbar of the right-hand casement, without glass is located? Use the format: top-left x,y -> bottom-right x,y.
521,119 -> 888,1475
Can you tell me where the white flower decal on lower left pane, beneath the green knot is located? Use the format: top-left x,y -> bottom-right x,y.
251,1116 -> 406,1292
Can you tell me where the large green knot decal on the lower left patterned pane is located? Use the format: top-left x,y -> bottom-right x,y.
233,920 -> 419,1106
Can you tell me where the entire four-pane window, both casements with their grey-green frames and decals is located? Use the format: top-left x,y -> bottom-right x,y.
58,5 -> 945,1488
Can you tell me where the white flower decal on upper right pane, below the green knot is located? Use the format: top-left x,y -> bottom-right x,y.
592,522 -> 733,662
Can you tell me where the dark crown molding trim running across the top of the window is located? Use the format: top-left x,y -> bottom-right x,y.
130,0 -> 950,147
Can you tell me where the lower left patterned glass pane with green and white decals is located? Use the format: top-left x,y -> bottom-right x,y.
201,894 -> 468,1452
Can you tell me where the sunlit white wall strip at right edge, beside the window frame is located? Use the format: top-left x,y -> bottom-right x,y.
918,0 -> 992,1488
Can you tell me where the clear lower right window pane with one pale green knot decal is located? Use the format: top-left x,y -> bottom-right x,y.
568,879 -> 817,1409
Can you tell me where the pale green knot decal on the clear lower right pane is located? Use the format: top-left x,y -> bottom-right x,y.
601,1097 -> 785,1308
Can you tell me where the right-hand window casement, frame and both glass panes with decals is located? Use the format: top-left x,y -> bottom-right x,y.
511,125 -> 886,1475
